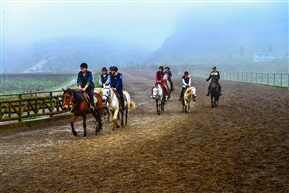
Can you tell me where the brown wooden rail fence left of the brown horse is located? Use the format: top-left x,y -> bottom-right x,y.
0,91 -> 67,122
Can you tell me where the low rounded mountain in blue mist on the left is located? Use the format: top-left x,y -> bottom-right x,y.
3,37 -> 152,73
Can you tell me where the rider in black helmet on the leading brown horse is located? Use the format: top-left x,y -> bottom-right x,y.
77,63 -> 94,111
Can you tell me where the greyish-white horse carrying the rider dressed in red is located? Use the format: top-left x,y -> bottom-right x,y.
152,83 -> 166,115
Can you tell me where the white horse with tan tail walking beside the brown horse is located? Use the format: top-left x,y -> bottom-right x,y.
102,87 -> 135,130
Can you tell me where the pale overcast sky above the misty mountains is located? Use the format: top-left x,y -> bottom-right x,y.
1,0 -> 193,47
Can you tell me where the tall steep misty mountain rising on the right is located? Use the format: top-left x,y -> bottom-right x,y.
145,3 -> 288,73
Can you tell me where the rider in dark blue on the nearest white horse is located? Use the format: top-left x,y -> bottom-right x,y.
109,66 -> 125,109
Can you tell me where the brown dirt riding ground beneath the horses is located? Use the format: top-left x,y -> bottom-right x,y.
0,71 -> 289,193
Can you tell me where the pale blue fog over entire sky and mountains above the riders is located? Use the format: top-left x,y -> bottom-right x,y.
1,0 -> 288,73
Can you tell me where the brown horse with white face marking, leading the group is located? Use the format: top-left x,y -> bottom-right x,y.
62,88 -> 103,137
